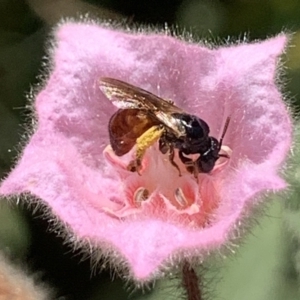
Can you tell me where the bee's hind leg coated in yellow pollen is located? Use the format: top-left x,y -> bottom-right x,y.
127,126 -> 164,175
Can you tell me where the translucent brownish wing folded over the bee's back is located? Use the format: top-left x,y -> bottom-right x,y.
100,77 -> 185,135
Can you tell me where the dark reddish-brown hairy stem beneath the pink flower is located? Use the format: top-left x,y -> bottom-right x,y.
182,261 -> 204,300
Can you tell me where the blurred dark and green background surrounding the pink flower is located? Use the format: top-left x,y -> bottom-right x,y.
0,0 -> 300,300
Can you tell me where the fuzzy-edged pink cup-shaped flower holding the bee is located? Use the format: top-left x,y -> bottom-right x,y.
0,23 -> 291,281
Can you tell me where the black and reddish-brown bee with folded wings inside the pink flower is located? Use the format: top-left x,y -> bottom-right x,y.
100,77 -> 230,178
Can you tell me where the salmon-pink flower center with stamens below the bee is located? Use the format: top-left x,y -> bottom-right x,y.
103,146 -> 231,227
